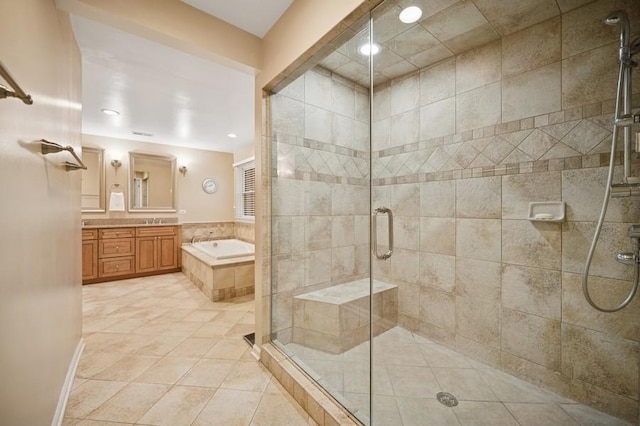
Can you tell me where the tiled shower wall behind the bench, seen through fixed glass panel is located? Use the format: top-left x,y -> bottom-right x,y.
271,68 -> 370,343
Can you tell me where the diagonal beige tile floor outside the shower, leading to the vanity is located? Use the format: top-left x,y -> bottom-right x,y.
63,273 -> 315,426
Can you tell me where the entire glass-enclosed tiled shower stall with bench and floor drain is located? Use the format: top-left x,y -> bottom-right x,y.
263,0 -> 640,425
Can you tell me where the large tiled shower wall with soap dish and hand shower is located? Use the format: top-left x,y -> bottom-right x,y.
372,1 -> 640,422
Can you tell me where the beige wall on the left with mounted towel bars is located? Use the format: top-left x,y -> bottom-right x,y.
0,0 -> 82,425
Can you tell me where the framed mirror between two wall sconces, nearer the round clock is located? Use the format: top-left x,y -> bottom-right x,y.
129,152 -> 176,212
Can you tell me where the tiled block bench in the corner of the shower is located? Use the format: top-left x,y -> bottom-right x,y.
293,278 -> 398,354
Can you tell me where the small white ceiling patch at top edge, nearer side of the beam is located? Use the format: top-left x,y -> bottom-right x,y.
182,0 -> 293,38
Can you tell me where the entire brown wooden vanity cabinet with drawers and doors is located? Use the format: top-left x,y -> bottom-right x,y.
82,226 -> 181,284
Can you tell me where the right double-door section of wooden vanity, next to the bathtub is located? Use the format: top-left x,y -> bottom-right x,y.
136,226 -> 179,272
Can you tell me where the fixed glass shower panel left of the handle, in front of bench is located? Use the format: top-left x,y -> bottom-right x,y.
270,11 -> 371,424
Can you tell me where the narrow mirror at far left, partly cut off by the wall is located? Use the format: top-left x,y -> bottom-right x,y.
81,146 -> 105,212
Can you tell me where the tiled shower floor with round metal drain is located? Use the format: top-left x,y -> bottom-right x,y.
281,327 -> 628,426
